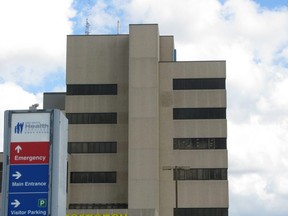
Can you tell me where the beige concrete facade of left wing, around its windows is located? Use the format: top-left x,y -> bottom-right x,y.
65,35 -> 129,209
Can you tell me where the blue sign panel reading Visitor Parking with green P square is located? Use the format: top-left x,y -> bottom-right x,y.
8,193 -> 48,216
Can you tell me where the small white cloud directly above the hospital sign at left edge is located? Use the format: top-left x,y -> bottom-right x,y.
0,82 -> 43,151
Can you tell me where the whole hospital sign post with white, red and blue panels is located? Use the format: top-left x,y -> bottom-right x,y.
2,110 -> 68,216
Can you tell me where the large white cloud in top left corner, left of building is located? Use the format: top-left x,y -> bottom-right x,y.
0,0 -> 74,86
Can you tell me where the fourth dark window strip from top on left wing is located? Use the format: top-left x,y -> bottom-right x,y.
70,172 -> 116,183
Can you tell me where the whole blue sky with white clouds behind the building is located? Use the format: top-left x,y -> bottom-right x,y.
0,0 -> 288,216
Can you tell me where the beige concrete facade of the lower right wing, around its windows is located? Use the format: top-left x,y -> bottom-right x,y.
159,61 -> 229,215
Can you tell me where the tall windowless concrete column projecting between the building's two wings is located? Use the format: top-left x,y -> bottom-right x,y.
128,24 -> 159,211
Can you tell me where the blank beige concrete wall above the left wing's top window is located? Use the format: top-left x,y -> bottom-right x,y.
66,35 -> 129,84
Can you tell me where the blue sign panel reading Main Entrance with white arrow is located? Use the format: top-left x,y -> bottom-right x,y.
9,164 -> 49,193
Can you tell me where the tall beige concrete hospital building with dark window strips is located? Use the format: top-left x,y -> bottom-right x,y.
44,24 -> 229,216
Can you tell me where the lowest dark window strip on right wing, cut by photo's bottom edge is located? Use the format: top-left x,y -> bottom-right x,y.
174,208 -> 228,216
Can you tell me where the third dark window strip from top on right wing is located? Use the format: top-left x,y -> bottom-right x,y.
173,138 -> 227,150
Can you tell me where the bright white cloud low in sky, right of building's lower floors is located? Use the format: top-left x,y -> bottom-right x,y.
228,116 -> 288,216
